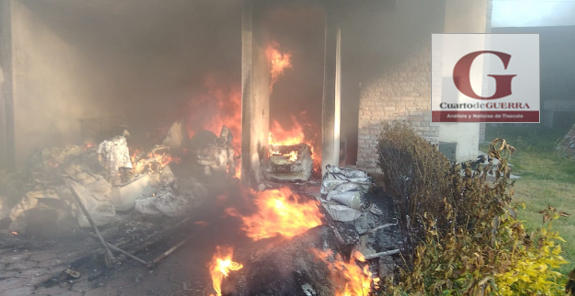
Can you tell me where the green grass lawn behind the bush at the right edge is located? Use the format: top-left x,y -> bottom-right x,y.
482,124 -> 575,274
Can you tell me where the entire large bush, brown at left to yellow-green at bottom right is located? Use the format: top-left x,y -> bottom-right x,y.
378,123 -> 567,295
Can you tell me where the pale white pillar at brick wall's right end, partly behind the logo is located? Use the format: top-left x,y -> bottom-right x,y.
439,0 -> 488,161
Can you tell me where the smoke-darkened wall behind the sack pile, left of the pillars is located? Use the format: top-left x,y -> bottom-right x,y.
0,0 -> 241,167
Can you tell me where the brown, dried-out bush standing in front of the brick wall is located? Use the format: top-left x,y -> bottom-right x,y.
378,122 -> 452,262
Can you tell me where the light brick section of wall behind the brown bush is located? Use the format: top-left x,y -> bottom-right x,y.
357,41 -> 439,170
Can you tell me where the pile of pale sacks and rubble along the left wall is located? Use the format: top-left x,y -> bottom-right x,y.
0,123 -> 216,234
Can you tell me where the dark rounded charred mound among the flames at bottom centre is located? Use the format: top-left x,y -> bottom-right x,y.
221,226 -> 338,296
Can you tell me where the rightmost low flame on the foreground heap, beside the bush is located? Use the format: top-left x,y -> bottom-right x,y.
312,249 -> 379,296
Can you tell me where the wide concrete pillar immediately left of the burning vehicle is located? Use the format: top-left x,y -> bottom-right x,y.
241,0 -> 270,188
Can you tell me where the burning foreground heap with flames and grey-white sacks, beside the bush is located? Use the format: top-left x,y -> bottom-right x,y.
211,166 -> 401,296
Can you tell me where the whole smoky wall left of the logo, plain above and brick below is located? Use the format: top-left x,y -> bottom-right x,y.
356,0 -> 492,171
